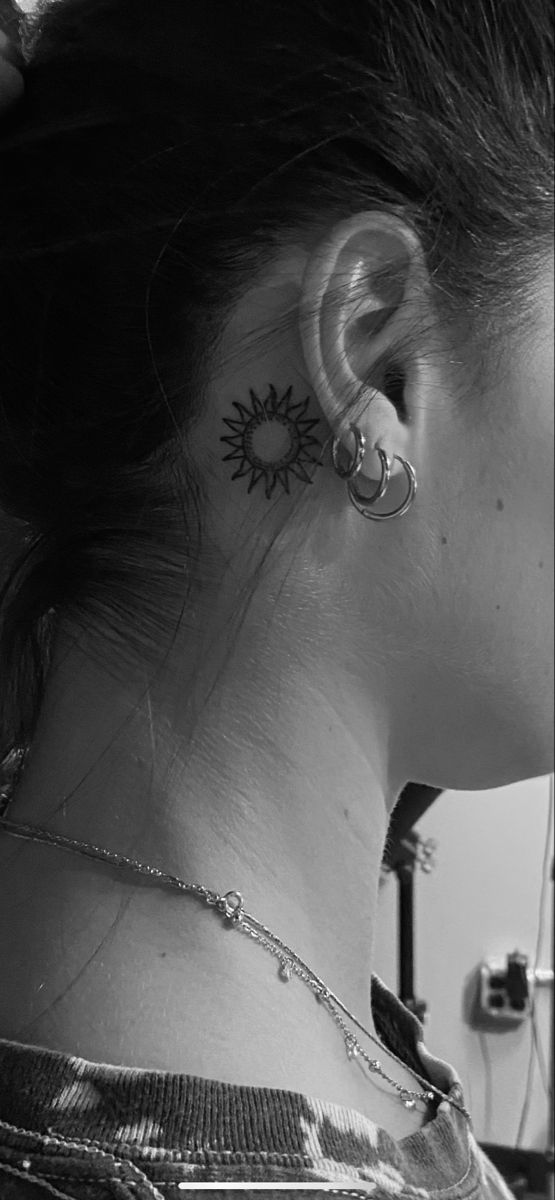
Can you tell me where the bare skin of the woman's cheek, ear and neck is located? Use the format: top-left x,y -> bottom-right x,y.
0,212 -> 554,1136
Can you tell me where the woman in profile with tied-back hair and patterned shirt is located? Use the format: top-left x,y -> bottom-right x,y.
0,0 -> 553,1200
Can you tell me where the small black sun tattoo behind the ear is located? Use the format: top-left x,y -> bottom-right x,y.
220,384 -> 322,500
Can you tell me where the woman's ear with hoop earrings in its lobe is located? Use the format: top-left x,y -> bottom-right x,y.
299,210 -> 428,476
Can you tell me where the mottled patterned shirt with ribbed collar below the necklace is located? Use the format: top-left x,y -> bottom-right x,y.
0,976 -> 513,1200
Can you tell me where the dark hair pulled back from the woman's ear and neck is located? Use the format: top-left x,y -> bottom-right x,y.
0,0 -> 553,758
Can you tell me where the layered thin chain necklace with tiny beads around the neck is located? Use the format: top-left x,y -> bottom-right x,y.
0,808 -> 471,1121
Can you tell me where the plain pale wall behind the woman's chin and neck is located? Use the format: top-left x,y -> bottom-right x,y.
375,776 -> 553,1151
